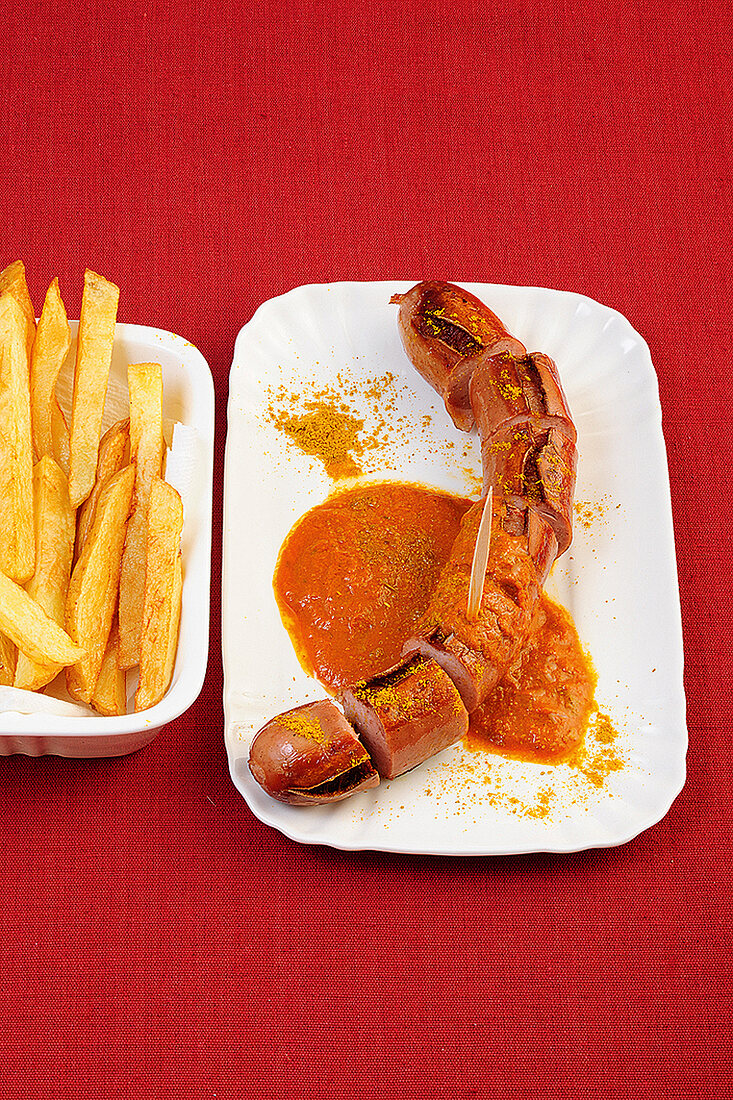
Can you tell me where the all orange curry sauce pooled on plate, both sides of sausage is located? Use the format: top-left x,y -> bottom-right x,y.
274,482 -> 595,763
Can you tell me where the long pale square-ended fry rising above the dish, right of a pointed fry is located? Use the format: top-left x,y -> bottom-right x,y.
68,271 -> 120,508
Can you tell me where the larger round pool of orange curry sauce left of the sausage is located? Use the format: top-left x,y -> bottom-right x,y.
274,482 -> 473,689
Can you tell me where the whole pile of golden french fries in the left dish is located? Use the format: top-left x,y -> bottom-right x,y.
0,261 -> 183,715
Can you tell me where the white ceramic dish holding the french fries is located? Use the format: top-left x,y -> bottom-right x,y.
0,321 -> 214,757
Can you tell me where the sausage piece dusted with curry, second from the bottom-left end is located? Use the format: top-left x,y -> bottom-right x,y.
341,657 -> 468,779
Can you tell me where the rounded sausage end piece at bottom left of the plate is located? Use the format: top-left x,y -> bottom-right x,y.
250,699 -> 380,806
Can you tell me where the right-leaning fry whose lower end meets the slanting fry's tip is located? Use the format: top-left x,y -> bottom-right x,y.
66,466 -> 135,703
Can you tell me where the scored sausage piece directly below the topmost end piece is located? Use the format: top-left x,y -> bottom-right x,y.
469,351 -> 577,444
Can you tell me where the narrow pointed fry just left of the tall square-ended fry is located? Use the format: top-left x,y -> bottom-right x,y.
31,278 -> 72,459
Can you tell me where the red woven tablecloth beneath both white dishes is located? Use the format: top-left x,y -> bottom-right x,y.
0,0 -> 733,1100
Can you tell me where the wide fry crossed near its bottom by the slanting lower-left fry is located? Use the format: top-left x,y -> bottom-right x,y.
13,454 -> 75,691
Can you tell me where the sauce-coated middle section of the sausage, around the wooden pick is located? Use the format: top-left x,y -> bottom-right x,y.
403,501 -> 540,713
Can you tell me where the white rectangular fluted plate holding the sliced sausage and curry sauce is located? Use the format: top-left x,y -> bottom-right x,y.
222,283 -> 687,855
